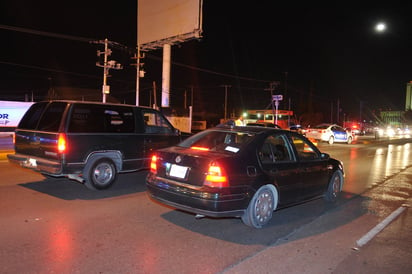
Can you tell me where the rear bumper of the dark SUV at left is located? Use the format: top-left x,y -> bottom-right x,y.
7,153 -> 63,176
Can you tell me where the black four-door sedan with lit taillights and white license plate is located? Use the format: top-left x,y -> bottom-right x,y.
146,123 -> 344,228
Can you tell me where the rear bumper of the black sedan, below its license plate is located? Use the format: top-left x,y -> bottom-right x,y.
146,173 -> 250,217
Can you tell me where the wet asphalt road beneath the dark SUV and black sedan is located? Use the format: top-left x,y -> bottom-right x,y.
0,134 -> 412,273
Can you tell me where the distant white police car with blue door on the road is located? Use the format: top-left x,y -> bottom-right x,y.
306,124 -> 353,144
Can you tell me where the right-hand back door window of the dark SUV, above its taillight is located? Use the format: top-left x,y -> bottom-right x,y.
37,102 -> 67,132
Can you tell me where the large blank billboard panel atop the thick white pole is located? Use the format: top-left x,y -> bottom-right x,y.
137,0 -> 202,50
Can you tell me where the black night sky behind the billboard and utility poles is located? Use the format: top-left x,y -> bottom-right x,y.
0,0 -> 412,123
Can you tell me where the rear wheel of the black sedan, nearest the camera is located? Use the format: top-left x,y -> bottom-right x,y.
242,185 -> 278,228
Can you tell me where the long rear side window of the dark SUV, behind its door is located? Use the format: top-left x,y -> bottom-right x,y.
68,104 -> 135,133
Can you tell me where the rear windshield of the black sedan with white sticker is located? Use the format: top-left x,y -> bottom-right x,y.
178,130 -> 254,153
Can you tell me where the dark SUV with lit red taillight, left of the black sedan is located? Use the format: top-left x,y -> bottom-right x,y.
7,101 -> 189,190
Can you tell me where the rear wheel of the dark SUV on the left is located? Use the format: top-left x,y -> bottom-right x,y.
84,158 -> 117,190
